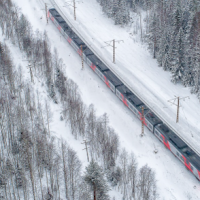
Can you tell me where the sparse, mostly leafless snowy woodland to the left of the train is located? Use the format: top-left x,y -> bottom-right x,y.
0,0 -> 158,200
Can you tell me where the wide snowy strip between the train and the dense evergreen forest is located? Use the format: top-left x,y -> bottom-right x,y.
55,0 -> 200,152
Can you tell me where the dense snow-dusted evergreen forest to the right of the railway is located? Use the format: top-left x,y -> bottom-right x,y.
97,0 -> 200,99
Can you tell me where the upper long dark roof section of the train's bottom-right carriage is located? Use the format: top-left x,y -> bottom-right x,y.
157,124 -> 187,150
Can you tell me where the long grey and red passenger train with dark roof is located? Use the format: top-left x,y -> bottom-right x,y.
48,8 -> 200,181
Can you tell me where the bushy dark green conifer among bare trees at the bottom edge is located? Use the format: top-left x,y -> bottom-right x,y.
84,160 -> 109,200
